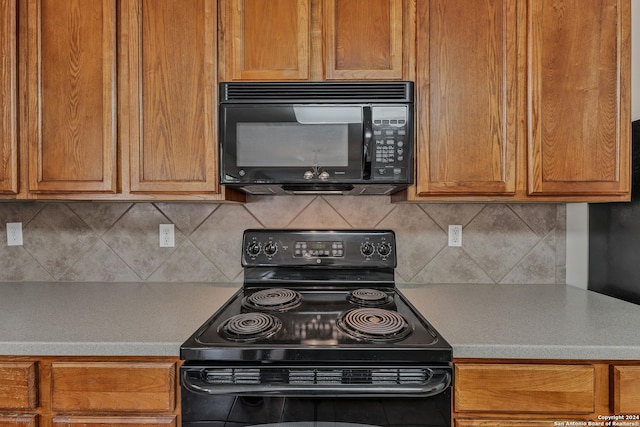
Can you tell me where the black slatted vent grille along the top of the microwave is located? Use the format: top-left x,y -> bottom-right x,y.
220,81 -> 413,103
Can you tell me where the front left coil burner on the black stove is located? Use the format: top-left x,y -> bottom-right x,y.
218,312 -> 282,342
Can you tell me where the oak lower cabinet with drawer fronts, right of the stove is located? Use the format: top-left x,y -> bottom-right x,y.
453,359 -> 640,427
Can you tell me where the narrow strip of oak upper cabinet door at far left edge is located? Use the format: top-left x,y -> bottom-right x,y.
0,0 -> 18,194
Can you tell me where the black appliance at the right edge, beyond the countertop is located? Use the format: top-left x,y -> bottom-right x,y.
588,120 -> 640,304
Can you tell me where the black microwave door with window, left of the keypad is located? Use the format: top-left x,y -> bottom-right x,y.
220,104 -> 371,184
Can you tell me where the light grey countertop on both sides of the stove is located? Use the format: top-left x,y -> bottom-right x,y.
0,282 -> 640,360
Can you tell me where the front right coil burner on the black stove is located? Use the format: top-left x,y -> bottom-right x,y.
336,307 -> 411,342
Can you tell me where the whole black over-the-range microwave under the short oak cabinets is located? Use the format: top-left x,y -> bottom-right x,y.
219,81 -> 414,195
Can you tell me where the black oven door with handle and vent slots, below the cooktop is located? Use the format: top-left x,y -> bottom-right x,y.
181,366 -> 451,427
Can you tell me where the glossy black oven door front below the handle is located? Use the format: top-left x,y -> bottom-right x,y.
182,389 -> 451,427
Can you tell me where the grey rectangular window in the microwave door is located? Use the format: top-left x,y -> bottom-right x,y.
236,122 -> 349,167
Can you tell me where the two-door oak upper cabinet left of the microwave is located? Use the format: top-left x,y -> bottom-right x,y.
21,0 -> 239,200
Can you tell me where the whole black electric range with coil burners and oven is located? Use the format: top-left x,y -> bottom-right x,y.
180,229 -> 453,427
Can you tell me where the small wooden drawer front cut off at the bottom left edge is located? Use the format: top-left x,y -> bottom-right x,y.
0,362 -> 38,409
